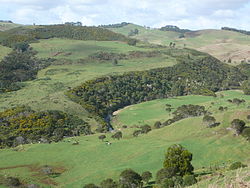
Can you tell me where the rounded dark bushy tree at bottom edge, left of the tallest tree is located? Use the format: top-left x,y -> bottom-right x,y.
119,169 -> 143,188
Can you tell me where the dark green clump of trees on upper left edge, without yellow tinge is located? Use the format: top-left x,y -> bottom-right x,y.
0,48 -> 53,93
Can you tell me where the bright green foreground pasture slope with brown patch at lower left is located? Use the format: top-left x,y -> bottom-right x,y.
0,91 -> 250,187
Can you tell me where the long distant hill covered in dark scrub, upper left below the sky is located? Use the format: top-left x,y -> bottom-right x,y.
0,24 -> 129,47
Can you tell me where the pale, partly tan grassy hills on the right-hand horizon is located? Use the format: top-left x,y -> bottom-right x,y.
111,24 -> 250,64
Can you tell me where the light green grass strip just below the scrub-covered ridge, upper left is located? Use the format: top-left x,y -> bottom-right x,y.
31,38 -> 147,60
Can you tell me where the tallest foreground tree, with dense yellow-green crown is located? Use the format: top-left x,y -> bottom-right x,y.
163,144 -> 194,176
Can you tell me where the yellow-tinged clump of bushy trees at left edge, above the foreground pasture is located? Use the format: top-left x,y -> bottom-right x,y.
0,106 -> 91,148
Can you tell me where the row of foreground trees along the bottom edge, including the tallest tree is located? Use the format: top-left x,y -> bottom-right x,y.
84,144 -> 197,188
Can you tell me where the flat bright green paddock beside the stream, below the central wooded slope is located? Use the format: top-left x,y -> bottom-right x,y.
113,91 -> 250,127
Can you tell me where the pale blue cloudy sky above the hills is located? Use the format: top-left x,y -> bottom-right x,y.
0,0 -> 250,30
